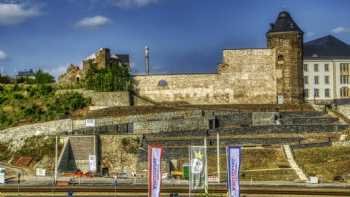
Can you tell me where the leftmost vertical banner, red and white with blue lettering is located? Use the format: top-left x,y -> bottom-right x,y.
148,145 -> 163,197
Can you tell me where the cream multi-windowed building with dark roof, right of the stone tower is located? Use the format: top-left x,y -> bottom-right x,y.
303,36 -> 350,104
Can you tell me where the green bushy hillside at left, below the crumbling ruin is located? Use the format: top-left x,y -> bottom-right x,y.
0,84 -> 90,129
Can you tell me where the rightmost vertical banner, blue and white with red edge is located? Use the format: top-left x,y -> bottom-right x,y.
226,146 -> 241,197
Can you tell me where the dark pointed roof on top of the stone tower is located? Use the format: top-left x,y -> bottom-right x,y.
268,11 -> 304,33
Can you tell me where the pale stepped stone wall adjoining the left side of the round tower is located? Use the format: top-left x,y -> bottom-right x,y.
134,49 -> 276,104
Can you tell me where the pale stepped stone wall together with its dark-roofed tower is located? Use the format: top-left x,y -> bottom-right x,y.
134,12 -> 303,104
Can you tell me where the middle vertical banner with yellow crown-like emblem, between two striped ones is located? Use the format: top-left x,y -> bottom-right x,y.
189,146 -> 208,191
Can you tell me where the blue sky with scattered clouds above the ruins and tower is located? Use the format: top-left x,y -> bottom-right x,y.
0,0 -> 350,76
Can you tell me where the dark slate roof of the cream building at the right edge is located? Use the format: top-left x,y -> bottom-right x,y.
304,35 -> 350,58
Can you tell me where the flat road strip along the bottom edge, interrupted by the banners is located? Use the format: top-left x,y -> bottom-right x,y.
0,185 -> 350,197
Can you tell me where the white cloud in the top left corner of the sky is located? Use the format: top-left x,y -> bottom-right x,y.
0,3 -> 40,25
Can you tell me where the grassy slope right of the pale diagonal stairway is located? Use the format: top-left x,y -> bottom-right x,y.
295,146 -> 350,182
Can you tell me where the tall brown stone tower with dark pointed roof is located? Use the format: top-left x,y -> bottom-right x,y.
266,11 -> 304,104
